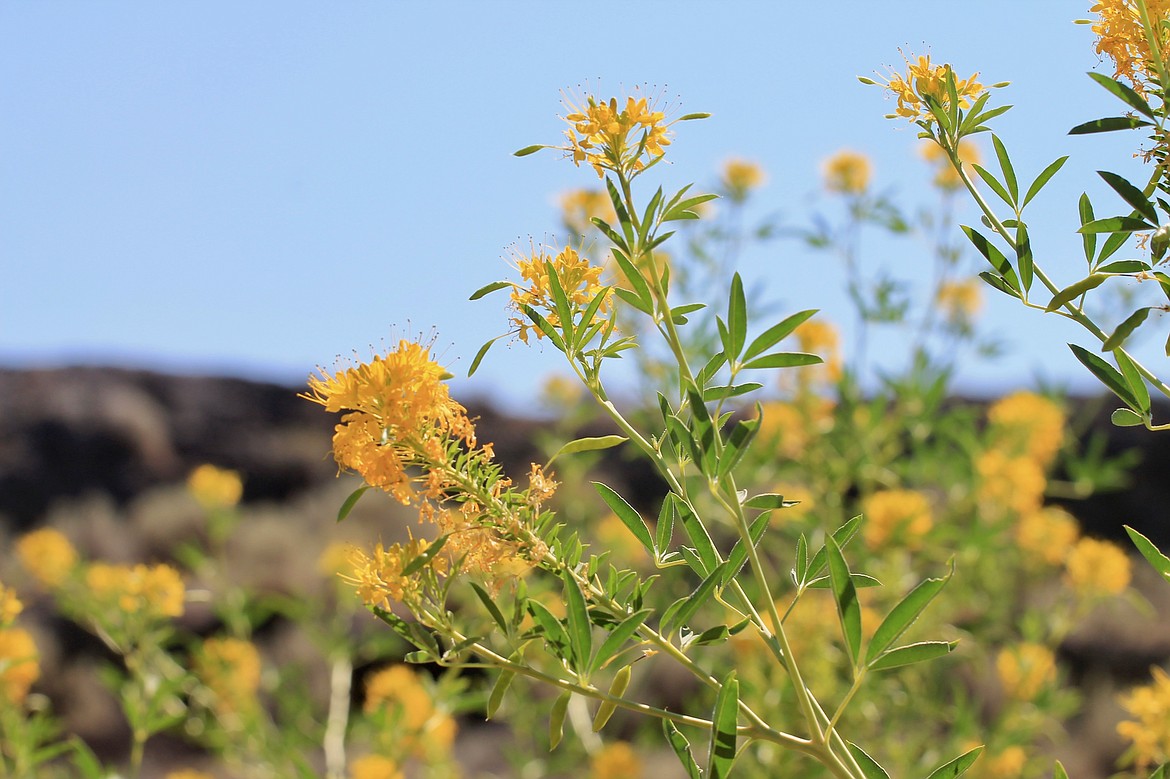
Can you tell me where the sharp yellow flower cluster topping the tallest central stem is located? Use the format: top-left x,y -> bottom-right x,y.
563,95 -> 670,178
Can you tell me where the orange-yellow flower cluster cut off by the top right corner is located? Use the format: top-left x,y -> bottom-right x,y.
1089,0 -> 1170,95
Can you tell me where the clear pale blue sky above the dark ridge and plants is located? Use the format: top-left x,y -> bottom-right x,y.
0,0 -> 1161,405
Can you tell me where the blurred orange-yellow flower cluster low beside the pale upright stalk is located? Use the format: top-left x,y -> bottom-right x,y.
363,666 -> 457,754
